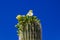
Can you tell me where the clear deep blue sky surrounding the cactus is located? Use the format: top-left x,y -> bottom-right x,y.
0,0 -> 60,40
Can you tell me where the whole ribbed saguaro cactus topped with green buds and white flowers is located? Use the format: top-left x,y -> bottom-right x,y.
16,10 -> 41,40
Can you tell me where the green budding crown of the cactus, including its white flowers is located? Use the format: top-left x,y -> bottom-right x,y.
15,10 -> 40,35
